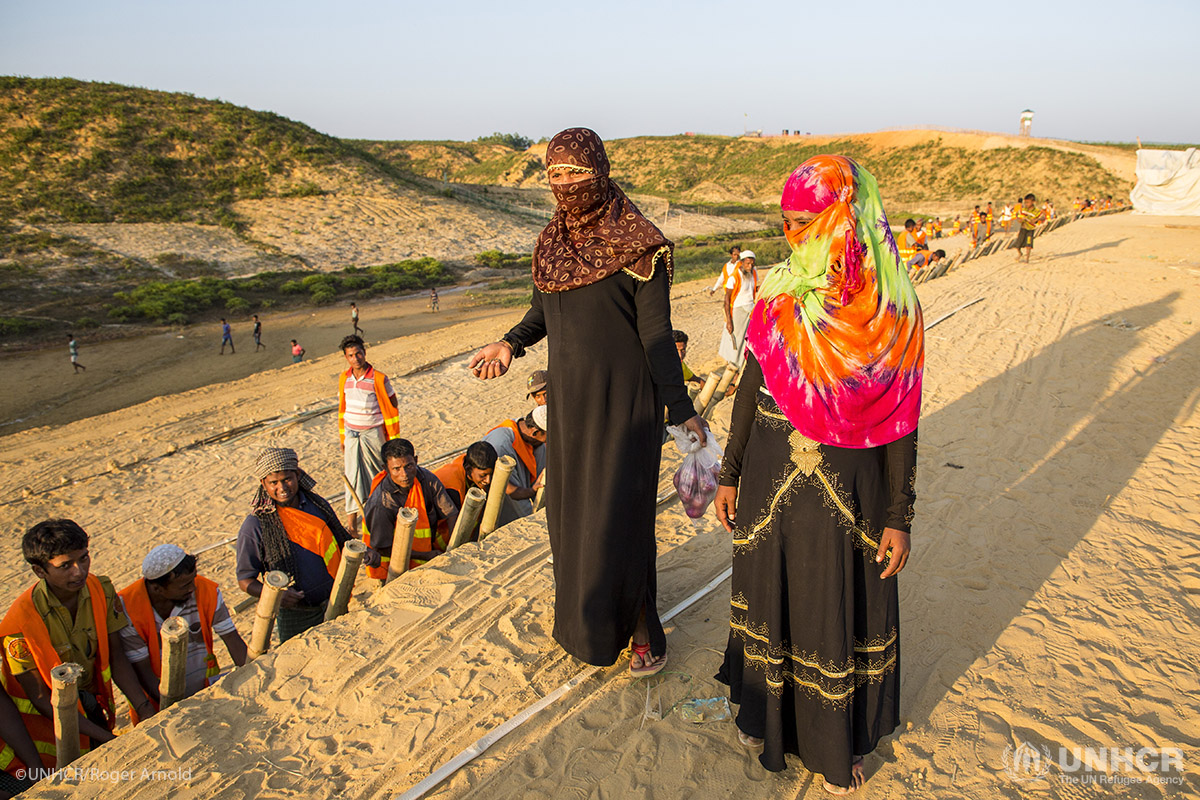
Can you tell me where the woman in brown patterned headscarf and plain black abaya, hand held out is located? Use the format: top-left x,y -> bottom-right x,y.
470,128 -> 706,675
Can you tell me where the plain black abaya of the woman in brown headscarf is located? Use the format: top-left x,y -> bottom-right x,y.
504,265 -> 696,666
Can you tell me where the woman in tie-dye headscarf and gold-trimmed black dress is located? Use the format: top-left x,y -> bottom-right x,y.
714,156 -> 924,794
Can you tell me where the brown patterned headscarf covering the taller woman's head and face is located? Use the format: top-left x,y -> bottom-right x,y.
533,128 -> 673,291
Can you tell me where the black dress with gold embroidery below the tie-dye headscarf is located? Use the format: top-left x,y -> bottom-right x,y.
718,355 -> 917,787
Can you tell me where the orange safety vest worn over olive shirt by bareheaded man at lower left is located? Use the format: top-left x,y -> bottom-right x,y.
0,575 -> 116,772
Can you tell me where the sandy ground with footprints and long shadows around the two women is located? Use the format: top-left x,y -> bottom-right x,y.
0,215 -> 1200,800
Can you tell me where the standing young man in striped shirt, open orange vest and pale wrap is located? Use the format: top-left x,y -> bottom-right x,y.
337,335 -> 400,530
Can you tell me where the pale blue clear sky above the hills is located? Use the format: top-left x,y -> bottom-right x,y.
0,0 -> 1200,142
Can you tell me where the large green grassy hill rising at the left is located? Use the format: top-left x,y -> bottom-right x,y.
0,77 -> 427,227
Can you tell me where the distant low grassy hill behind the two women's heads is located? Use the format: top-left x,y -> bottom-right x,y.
360,136 -> 1129,207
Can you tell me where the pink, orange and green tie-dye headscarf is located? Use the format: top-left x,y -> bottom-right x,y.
746,156 -> 925,447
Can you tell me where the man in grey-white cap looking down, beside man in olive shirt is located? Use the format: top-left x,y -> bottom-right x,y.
120,545 -> 246,724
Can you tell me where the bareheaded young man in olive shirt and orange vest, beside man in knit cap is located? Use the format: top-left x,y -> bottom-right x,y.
0,519 -> 155,772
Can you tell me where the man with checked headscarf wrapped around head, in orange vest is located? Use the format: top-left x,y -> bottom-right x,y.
238,447 -> 379,643
